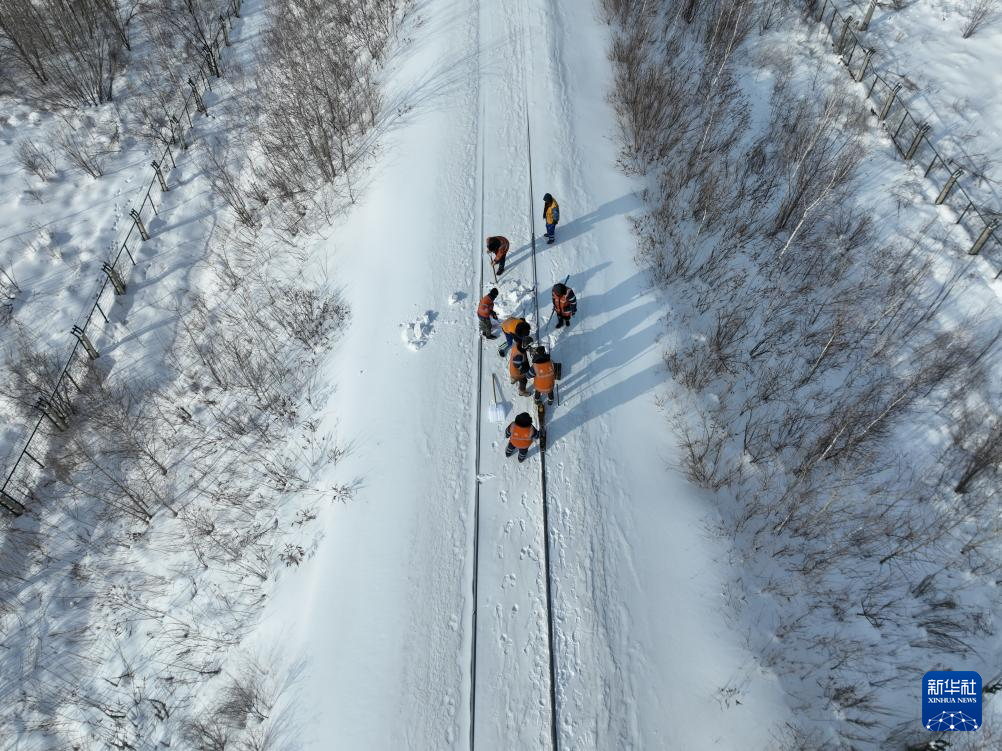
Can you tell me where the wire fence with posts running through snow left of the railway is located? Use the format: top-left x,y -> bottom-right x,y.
0,0 -> 241,516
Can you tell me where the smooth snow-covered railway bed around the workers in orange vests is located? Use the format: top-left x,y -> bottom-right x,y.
254,0 -> 783,749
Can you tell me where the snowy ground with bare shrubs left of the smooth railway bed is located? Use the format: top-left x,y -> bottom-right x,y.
0,0 -> 394,748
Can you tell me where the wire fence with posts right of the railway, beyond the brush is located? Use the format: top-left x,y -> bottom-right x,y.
808,0 -> 1002,270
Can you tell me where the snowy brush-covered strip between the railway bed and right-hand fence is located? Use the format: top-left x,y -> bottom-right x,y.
606,0 -> 1002,749
